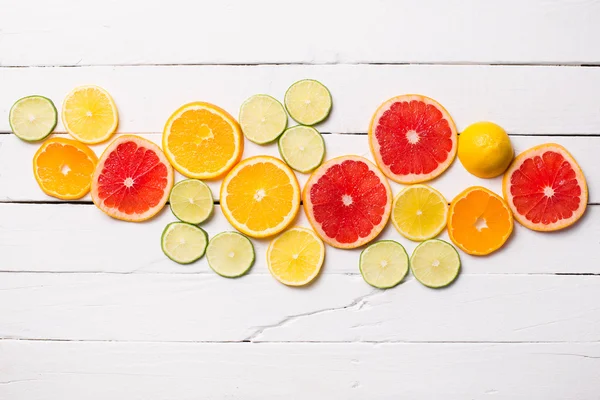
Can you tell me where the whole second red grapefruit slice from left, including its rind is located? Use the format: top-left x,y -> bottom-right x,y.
302,156 -> 392,249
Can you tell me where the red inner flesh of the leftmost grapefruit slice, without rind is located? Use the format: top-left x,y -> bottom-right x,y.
98,141 -> 168,215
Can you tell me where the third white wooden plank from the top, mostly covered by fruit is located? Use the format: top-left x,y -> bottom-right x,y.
0,133 -> 600,204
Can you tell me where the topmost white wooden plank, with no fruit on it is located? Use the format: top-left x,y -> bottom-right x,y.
0,0 -> 600,65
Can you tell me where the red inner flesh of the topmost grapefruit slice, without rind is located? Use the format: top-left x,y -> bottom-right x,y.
374,100 -> 453,175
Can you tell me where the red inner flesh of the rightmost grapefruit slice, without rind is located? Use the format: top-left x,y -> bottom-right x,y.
510,151 -> 582,225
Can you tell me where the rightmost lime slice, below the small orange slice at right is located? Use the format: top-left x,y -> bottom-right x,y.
410,239 -> 460,288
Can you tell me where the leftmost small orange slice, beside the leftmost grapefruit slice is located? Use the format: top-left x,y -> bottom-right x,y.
33,137 -> 98,200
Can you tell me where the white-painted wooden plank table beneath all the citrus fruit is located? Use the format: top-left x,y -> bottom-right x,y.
0,0 -> 600,400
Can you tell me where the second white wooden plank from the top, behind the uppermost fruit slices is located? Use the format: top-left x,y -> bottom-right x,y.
0,65 -> 600,135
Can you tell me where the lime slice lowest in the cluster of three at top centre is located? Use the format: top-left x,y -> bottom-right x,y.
278,125 -> 325,172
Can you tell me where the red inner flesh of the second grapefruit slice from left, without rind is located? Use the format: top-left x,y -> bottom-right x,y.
309,160 -> 389,243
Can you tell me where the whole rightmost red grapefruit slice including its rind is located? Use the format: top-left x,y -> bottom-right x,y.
502,143 -> 588,231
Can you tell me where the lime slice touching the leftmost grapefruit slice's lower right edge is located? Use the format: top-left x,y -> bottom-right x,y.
169,179 -> 213,224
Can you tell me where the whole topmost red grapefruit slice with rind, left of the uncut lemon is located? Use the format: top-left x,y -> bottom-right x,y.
369,94 -> 457,183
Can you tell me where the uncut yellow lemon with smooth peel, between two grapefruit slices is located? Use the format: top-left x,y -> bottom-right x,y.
458,121 -> 514,178
